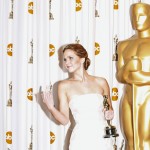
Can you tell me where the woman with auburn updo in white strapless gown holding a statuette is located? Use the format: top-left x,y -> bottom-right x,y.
42,44 -> 113,150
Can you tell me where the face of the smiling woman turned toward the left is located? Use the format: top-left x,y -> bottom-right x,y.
64,49 -> 84,73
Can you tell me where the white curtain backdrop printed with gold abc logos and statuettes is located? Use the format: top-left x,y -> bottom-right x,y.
0,0 -> 150,150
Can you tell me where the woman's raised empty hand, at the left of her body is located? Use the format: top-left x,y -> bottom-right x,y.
41,91 -> 54,110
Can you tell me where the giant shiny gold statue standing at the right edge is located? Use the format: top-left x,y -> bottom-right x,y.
116,3 -> 150,150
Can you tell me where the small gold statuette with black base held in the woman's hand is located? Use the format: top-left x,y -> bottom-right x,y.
103,95 -> 119,138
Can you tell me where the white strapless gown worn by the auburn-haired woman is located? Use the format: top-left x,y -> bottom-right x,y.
69,93 -> 113,150
